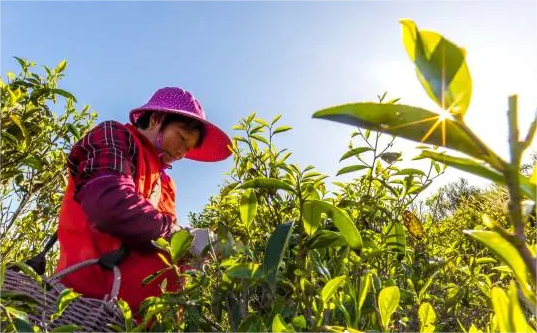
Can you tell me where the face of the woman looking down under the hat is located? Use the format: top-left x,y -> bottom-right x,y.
162,121 -> 200,163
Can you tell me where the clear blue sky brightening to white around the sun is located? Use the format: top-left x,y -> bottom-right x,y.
0,0 -> 537,223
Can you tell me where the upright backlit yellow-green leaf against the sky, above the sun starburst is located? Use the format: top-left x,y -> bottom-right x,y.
400,20 -> 472,118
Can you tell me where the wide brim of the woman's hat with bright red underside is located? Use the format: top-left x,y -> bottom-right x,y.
129,106 -> 231,162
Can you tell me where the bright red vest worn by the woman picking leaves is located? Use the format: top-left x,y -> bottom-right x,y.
57,125 -> 182,313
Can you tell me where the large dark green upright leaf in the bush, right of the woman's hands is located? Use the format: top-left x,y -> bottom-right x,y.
263,222 -> 294,292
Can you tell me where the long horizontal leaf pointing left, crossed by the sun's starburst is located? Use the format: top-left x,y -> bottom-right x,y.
313,103 -> 488,158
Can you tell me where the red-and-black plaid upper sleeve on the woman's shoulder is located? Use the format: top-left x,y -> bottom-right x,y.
67,121 -> 136,196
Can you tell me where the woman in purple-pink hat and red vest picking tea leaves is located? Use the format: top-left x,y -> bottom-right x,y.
57,87 -> 231,313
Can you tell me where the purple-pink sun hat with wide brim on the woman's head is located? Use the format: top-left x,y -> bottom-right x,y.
129,87 -> 231,162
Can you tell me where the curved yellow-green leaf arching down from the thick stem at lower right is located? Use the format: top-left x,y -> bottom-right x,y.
464,230 -> 530,290
